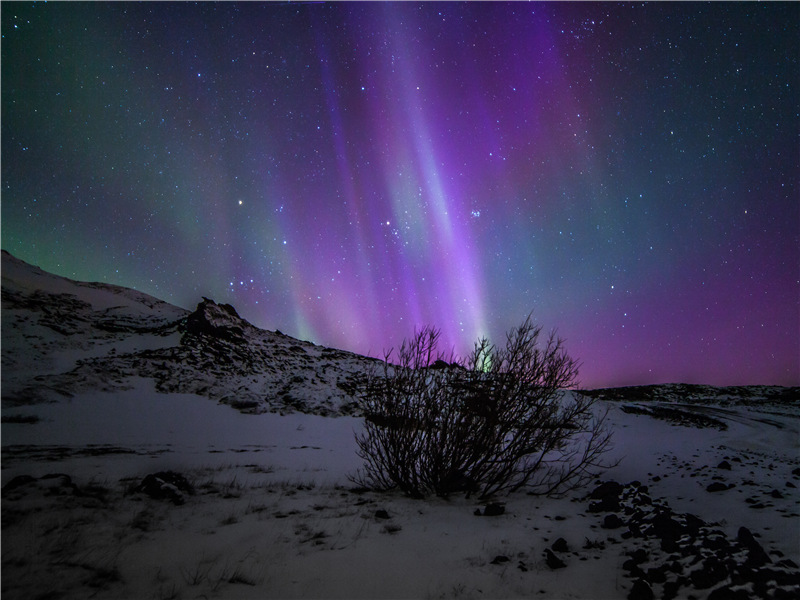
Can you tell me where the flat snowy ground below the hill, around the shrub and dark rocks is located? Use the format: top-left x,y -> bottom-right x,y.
2,380 -> 800,598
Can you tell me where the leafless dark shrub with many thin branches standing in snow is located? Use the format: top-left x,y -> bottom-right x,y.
352,316 -> 611,498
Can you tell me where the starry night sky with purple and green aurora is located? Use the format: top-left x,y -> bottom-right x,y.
2,2 -> 800,387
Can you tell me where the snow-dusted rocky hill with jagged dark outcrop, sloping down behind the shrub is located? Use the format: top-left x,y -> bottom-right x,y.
2,251 -> 375,415
